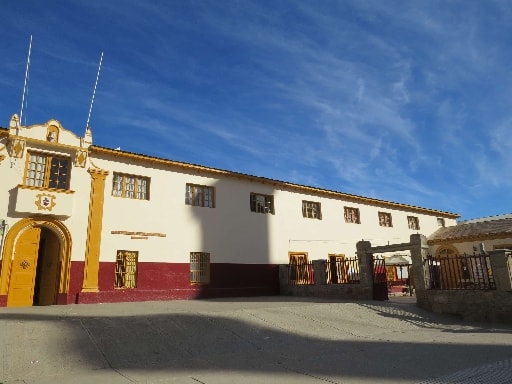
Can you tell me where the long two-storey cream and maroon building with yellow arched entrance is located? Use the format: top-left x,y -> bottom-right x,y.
0,115 -> 458,306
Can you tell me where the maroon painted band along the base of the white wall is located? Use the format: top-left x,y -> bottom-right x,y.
0,262 -> 279,307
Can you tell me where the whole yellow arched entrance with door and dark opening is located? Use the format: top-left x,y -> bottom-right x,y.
0,218 -> 71,306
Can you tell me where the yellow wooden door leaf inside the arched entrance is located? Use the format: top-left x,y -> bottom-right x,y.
7,228 -> 41,307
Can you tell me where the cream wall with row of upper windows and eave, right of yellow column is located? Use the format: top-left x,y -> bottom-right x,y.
90,146 -> 457,263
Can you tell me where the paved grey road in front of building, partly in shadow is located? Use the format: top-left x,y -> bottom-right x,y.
0,296 -> 512,384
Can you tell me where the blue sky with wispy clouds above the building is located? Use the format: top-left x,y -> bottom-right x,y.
0,0 -> 512,219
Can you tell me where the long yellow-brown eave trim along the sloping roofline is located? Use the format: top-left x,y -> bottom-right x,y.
89,145 -> 460,219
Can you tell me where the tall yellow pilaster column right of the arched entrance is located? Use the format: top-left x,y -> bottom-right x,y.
82,168 -> 109,292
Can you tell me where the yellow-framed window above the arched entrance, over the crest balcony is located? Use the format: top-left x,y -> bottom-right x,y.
25,153 -> 71,189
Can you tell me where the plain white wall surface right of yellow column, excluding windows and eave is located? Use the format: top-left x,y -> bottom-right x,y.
93,154 -> 455,264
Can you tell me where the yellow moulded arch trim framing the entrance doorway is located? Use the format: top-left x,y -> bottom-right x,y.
0,216 -> 72,295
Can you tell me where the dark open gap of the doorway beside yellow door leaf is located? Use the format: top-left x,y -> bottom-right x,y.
37,230 -> 60,305
